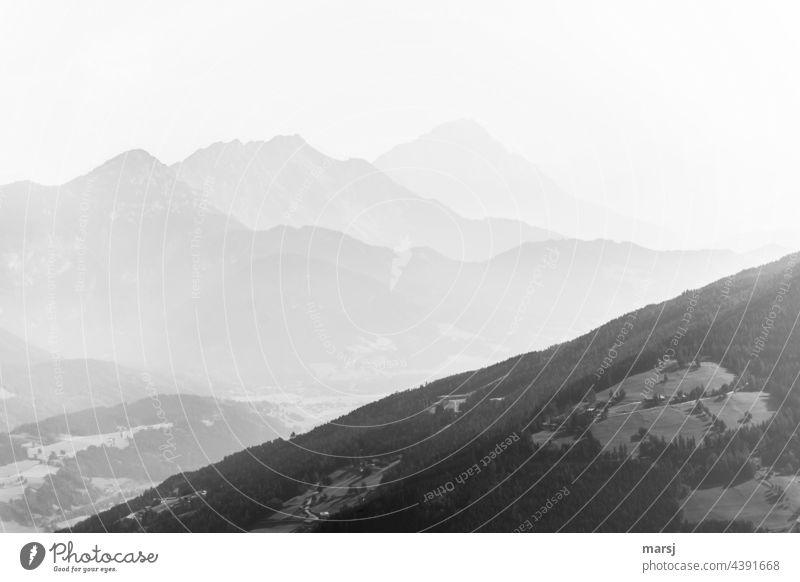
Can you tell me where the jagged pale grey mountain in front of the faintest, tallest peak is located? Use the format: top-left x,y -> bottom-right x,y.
172,136 -> 560,261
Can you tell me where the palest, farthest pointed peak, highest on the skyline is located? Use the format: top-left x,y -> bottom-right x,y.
375,120 -> 659,240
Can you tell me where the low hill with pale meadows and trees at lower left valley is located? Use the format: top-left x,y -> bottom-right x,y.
0,393 -> 290,531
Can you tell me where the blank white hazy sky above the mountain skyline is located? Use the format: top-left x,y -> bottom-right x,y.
0,0 -> 800,247
